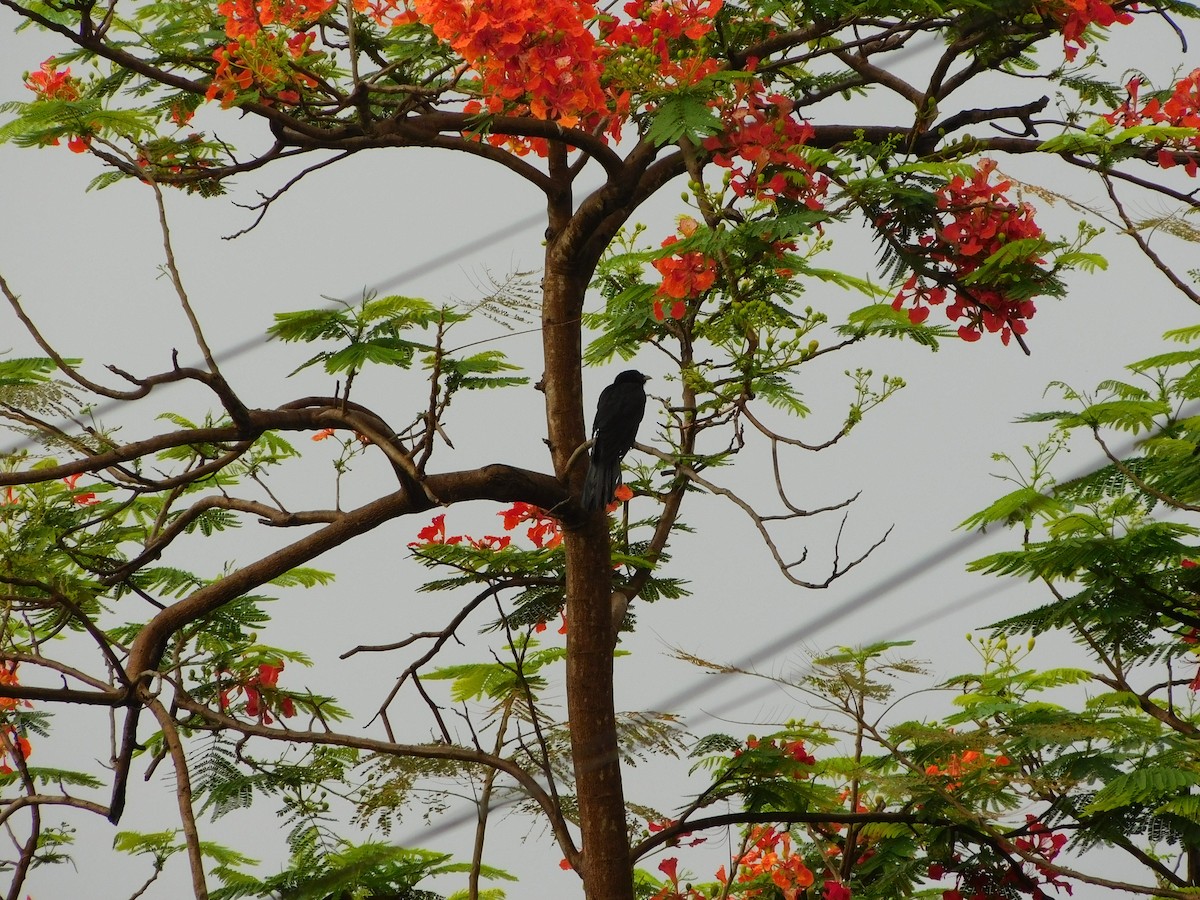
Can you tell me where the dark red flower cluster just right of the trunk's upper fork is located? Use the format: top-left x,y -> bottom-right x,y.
704,80 -> 829,210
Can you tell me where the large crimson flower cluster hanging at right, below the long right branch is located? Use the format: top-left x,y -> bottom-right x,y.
881,160 -> 1043,346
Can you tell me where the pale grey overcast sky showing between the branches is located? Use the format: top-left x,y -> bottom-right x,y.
0,12 -> 1196,900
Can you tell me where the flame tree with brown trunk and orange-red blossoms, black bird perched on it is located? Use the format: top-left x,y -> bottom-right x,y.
0,0 -> 1200,900
